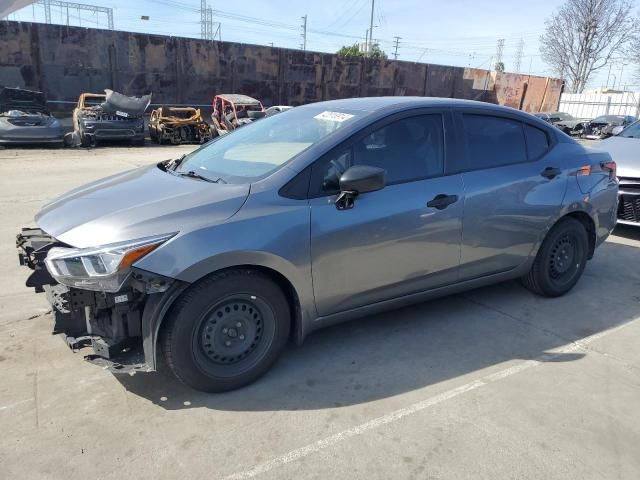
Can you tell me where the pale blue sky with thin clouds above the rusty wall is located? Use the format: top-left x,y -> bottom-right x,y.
10,0 -> 640,90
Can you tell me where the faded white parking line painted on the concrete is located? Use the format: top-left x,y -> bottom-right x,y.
223,318 -> 639,480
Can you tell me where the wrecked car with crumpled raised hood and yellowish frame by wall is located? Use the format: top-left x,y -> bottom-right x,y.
68,89 -> 151,147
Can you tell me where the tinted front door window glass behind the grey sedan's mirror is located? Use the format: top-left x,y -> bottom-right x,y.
313,114 -> 444,194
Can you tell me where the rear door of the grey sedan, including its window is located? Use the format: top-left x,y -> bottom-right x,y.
456,110 -> 567,280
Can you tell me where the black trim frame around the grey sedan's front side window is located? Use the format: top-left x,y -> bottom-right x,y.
307,107 -> 451,198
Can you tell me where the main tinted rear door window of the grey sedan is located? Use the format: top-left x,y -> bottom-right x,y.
464,114 -> 527,170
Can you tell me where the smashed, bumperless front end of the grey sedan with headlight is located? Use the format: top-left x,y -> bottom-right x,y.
16,228 -> 187,374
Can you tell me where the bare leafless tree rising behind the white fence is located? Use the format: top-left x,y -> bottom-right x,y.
540,0 -> 637,93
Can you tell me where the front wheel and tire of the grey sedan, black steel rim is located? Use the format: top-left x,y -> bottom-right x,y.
161,270 -> 291,392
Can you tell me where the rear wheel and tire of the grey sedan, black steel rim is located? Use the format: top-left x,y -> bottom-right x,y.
522,218 -> 589,297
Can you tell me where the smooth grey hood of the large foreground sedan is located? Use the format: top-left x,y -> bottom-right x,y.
36,165 -> 249,248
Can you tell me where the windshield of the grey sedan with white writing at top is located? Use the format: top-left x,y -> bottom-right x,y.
176,107 -> 364,183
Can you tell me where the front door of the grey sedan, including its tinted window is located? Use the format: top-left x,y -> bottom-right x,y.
310,111 -> 464,316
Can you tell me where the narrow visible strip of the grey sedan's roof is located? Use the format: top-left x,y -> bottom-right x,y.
297,97 -> 524,114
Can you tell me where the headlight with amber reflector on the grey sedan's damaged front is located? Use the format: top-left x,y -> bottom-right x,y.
46,233 -> 175,292
